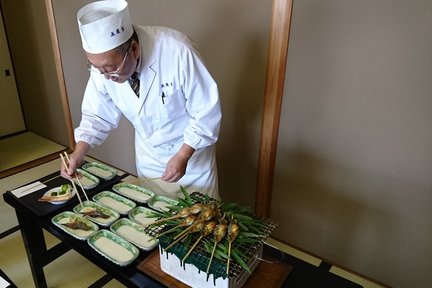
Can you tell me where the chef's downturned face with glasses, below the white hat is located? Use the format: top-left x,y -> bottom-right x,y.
86,40 -> 139,83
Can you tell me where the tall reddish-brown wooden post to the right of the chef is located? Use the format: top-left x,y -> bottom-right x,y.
255,0 -> 294,217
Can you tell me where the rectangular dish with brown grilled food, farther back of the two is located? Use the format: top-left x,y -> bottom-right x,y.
73,201 -> 120,226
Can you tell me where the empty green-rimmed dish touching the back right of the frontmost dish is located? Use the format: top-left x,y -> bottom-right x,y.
110,218 -> 159,251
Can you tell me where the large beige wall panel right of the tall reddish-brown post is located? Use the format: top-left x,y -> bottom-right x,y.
271,0 -> 432,287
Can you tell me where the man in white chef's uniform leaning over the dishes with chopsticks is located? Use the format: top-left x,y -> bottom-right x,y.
61,0 -> 221,198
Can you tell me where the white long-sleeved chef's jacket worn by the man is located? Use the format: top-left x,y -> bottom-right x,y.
75,26 -> 222,198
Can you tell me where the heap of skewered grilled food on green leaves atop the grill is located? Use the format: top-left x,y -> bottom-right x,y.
146,187 -> 276,277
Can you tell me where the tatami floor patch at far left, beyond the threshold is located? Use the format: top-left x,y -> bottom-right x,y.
0,132 -> 65,172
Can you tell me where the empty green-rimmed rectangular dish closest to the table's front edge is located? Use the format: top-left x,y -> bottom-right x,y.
87,229 -> 139,266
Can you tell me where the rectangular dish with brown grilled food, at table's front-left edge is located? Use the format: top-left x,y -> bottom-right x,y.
51,211 -> 99,240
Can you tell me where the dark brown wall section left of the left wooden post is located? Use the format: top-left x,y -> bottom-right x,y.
1,0 -> 68,146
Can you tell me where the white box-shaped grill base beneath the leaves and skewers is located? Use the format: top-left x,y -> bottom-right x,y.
159,245 -> 262,288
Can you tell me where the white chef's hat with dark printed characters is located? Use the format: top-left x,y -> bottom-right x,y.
77,0 -> 133,54
